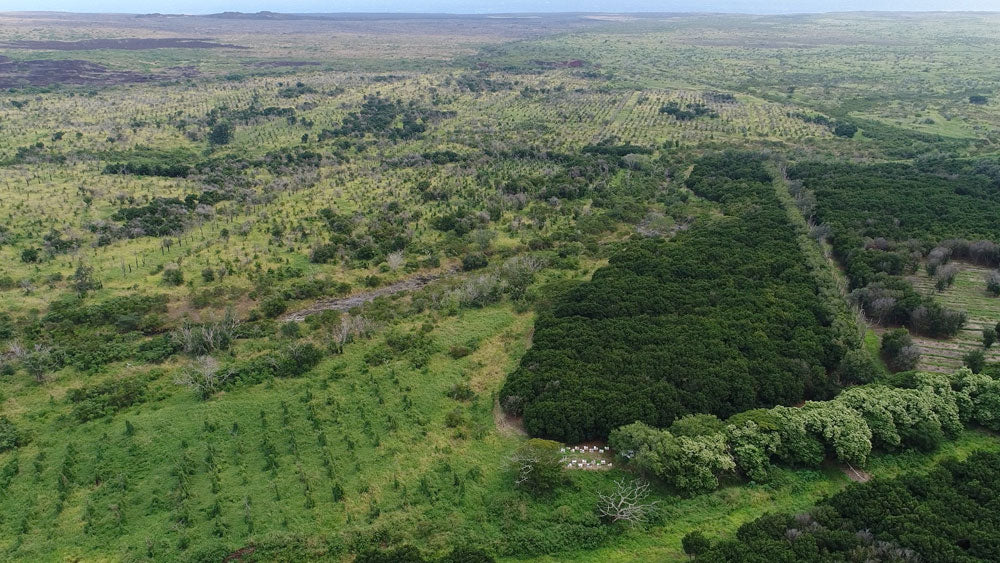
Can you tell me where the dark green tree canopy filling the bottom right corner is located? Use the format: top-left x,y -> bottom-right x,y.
683,451 -> 1000,563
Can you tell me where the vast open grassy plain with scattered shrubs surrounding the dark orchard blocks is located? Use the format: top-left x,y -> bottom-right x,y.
0,9 -> 1000,562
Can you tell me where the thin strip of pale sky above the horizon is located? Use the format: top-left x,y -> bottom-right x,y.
0,0 -> 1000,14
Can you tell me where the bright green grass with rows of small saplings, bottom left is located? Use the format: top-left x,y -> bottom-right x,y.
0,308 -> 531,560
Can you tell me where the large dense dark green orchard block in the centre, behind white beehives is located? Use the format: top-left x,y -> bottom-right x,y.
500,153 -> 848,442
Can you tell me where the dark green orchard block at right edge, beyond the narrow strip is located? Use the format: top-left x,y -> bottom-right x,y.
789,158 -> 1000,337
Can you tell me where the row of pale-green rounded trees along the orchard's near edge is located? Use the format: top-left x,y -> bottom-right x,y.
609,368 -> 1000,494
